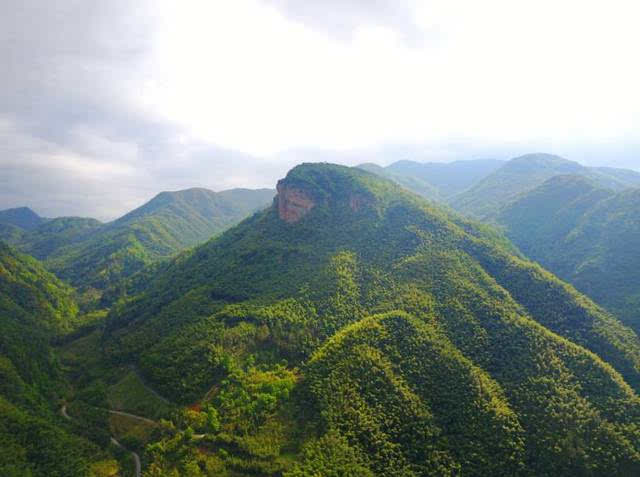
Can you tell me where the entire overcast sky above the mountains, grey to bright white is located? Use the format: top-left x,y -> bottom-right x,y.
0,0 -> 640,219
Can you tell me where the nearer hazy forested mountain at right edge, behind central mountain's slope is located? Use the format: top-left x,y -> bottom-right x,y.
497,176 -> 640,333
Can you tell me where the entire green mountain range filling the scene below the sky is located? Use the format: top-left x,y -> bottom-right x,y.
0,158 -> 640,477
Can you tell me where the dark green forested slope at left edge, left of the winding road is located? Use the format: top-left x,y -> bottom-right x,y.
0,243 -> 117,477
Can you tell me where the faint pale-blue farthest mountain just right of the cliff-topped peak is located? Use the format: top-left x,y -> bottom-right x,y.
358,159 -> 504,201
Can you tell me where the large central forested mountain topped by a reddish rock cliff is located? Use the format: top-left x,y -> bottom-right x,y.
95,164 -> 640,477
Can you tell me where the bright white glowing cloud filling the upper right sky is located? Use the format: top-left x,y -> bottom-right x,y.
140,0 -> 640,154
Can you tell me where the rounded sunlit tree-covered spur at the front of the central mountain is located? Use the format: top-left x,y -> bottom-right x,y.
302,312 -> 524,476
